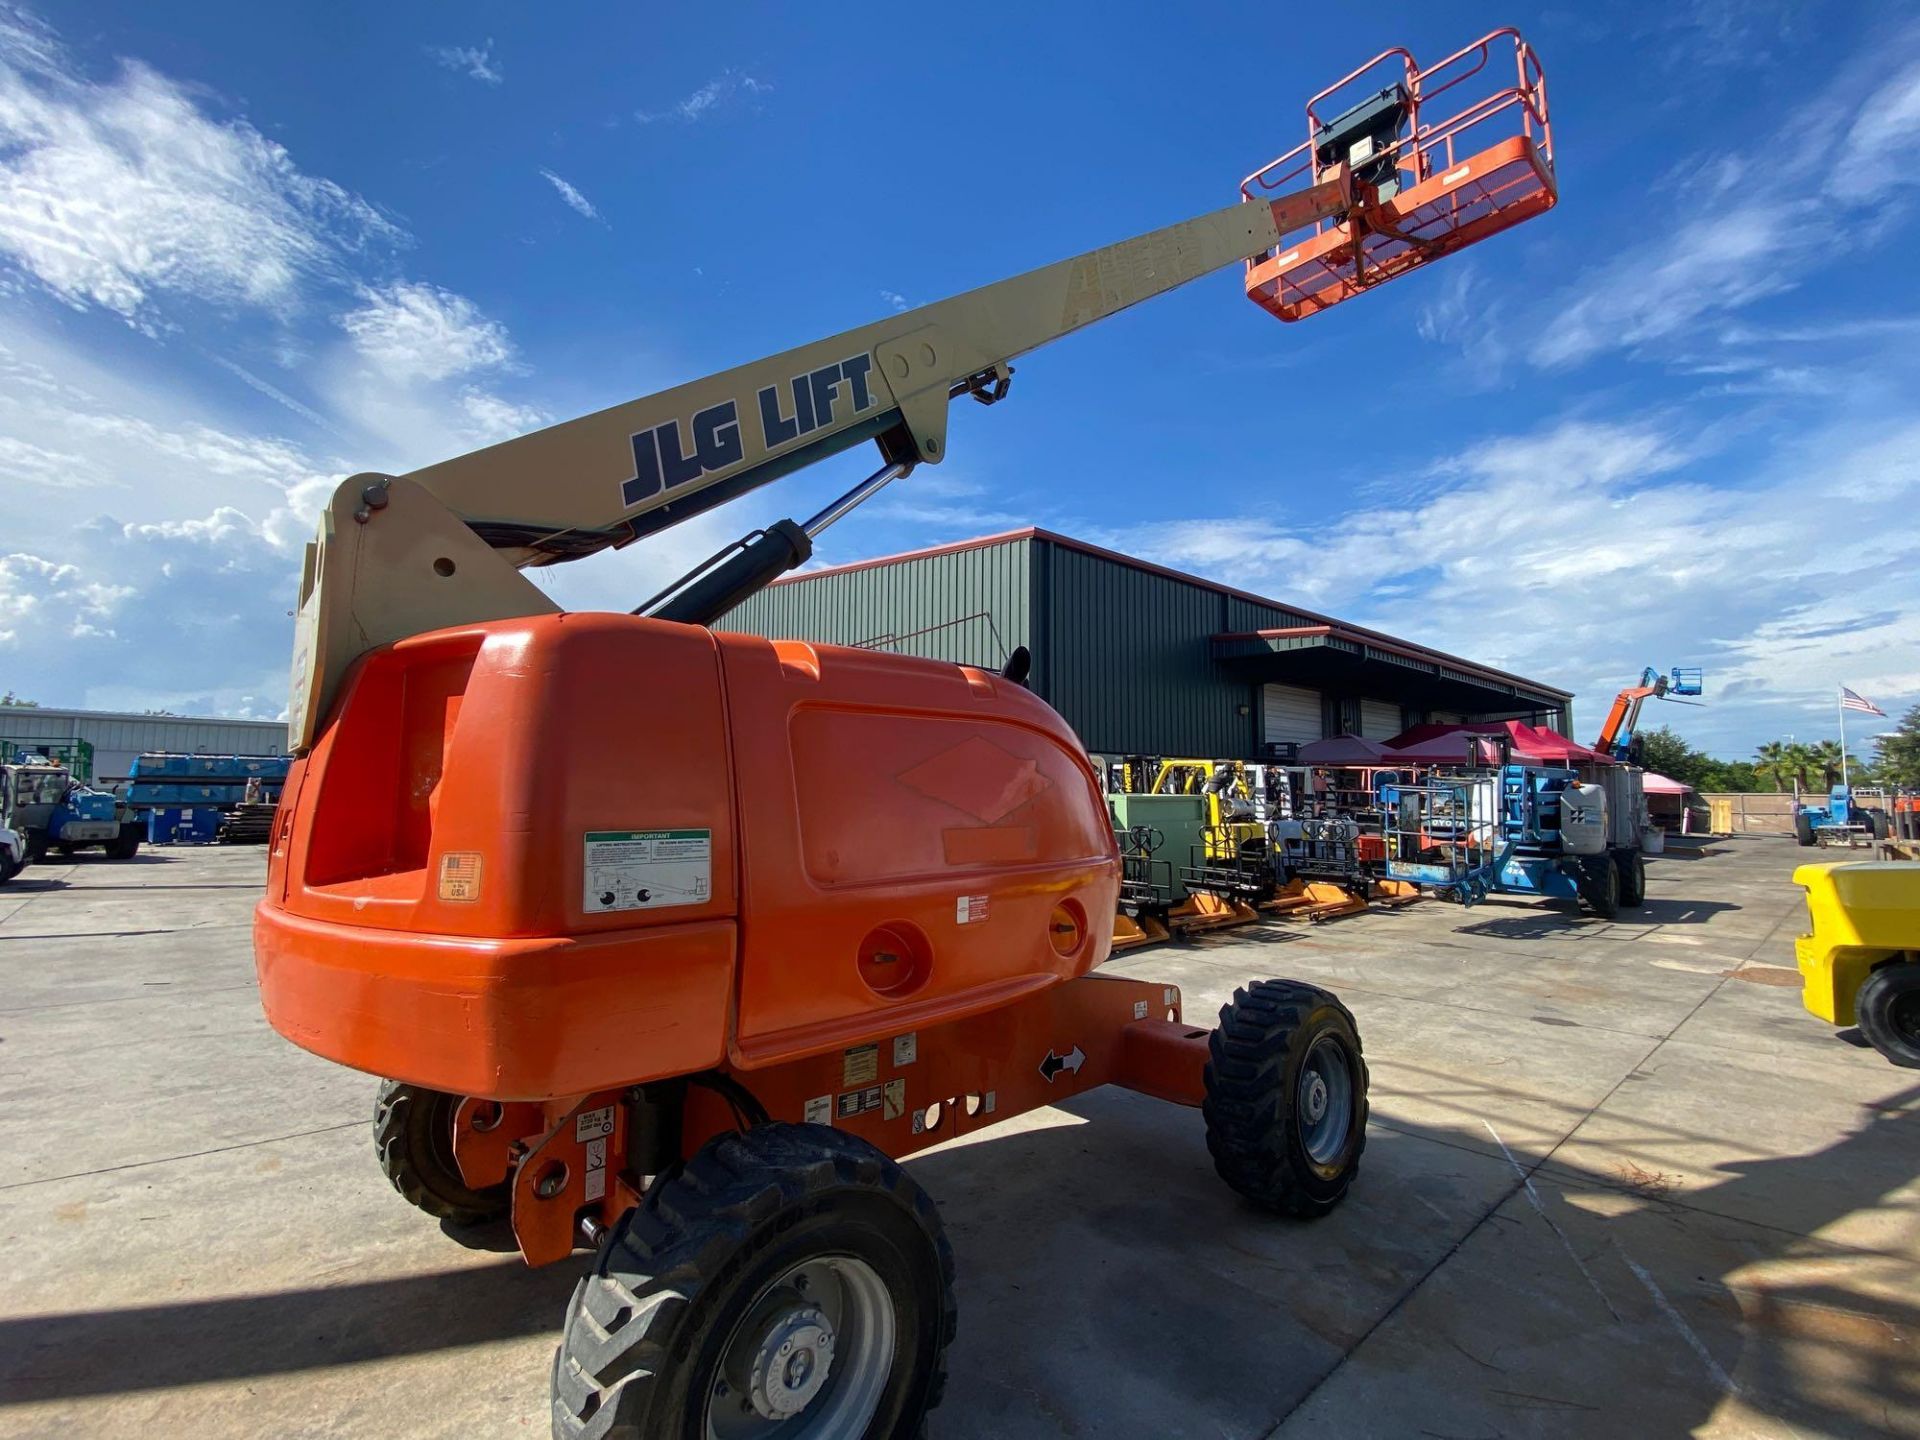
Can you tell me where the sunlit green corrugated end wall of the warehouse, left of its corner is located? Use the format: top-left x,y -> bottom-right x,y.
714,540 -> 1033,670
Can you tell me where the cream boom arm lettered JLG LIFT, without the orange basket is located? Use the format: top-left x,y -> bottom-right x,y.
290,174 -> 1352,751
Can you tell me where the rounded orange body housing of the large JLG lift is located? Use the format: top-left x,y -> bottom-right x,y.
253,614 -> 1119,1100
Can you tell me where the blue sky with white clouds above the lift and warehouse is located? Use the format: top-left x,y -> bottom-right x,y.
0,0 -> 1920,755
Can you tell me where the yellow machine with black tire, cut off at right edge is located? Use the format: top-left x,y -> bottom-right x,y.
1793,860 -> 1920,1069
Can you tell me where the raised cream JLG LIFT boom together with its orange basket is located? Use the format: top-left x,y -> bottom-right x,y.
290,29 -> 1559,751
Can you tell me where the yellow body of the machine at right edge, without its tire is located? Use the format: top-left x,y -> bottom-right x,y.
1793,860 -> 1920,1025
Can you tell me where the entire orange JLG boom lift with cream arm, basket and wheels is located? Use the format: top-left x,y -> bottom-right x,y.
253,31 -> 1553,1440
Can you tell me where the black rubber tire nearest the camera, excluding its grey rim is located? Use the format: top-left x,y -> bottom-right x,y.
553,1123 -> 956,1440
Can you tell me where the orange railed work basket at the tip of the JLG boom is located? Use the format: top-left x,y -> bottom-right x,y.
1240,29 -> 1559,321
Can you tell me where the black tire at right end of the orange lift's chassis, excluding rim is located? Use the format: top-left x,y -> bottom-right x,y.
1200,979 -> 1367,1219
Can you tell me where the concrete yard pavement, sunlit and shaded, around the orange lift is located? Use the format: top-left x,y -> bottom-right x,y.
0,839 -> 1920,1440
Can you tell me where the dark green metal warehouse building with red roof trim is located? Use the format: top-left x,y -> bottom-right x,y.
716,530 -> 1572,760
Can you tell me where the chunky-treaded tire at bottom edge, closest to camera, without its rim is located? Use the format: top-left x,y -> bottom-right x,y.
553,1123 -> 958,1440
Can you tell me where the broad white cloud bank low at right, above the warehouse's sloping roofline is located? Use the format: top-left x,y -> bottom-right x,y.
1085,419 -> 1920,755
